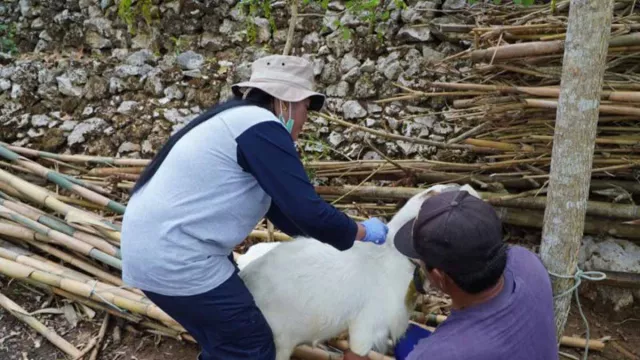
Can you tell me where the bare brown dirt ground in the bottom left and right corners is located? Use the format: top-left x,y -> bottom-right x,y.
0,278 -> 640,360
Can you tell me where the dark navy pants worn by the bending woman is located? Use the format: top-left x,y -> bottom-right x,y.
144,258 -> 276,360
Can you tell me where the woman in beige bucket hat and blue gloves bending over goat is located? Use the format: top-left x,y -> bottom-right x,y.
121,55 -> 387,360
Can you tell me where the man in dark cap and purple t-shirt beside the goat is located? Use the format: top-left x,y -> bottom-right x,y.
394,191 -> 558,360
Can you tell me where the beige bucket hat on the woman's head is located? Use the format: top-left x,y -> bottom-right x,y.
231,55 -> 325,111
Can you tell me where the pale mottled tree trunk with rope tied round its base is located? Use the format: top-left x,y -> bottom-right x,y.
540,0 -> 613,339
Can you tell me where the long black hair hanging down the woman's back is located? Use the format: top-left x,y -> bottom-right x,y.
131,88 -> 274,195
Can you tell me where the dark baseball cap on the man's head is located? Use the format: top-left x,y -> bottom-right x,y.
394,190 -> 507,277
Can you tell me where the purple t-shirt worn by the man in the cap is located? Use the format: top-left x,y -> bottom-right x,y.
407,246 -> 558,360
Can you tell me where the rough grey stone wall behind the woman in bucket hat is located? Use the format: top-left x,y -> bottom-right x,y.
0,0 -> 467,158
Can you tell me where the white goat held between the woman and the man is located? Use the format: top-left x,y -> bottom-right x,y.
238,185 -> 478,360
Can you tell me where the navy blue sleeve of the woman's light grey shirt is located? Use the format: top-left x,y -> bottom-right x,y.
236,121 -> 358,250
